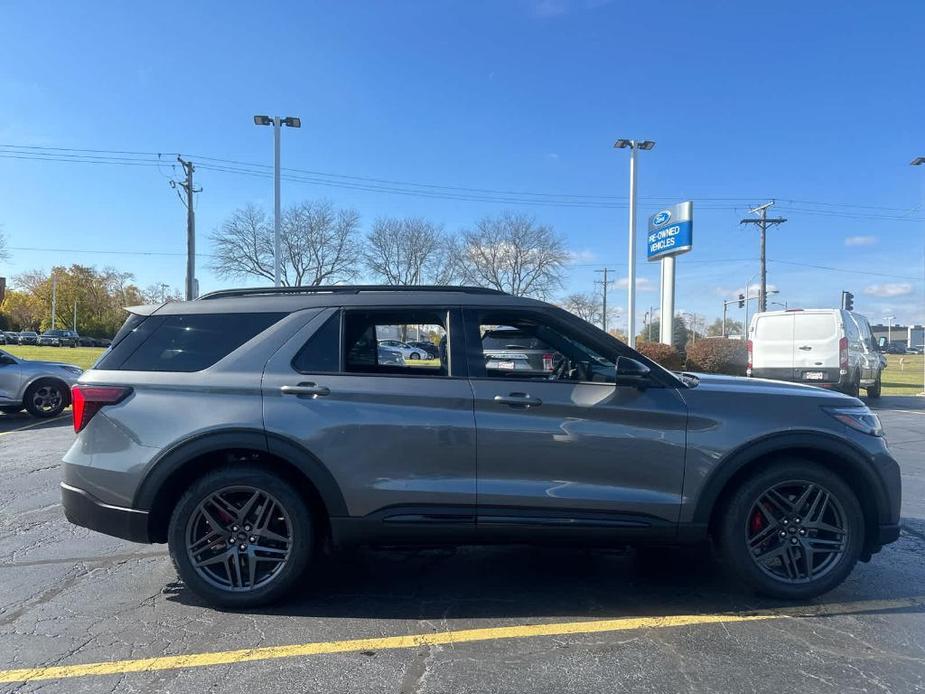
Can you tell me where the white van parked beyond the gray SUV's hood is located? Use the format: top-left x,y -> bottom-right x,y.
747,308 -> 886,398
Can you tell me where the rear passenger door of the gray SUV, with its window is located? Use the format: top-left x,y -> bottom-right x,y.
263,306 -> 476,539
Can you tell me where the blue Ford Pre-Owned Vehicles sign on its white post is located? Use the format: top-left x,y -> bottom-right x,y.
646,200 -> 694,345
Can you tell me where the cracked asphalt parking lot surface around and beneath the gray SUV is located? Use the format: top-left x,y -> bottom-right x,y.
0,397 -> 925,694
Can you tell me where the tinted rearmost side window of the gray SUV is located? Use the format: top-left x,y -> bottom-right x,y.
96,313 -> 285,372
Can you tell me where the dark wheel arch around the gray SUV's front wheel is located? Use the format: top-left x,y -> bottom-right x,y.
692,432 -> 889,555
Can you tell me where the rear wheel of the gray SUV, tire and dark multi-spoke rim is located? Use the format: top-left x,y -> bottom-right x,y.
167,465 -> 314,609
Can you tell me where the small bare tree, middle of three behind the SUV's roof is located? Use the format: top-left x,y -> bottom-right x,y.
363,217 -> 457,285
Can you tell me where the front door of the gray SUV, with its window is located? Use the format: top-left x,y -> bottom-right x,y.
464,308 -> 687,538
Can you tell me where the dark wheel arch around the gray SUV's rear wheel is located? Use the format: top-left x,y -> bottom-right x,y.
132,429 -> 347,542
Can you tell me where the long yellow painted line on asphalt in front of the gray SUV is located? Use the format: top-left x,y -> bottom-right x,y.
0,596 -> 925,682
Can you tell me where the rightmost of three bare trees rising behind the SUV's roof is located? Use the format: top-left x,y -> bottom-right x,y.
459,212 -> 570,298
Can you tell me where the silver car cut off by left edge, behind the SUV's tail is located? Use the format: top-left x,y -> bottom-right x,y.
0,349 -> 83,417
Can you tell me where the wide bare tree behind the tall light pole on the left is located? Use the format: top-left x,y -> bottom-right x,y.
210,200 -> 361,287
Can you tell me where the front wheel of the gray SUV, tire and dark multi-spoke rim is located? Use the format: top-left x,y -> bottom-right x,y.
716,460 -> 864,600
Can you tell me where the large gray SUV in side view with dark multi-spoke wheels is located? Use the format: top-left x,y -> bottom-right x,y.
61,286 -> 900,607
